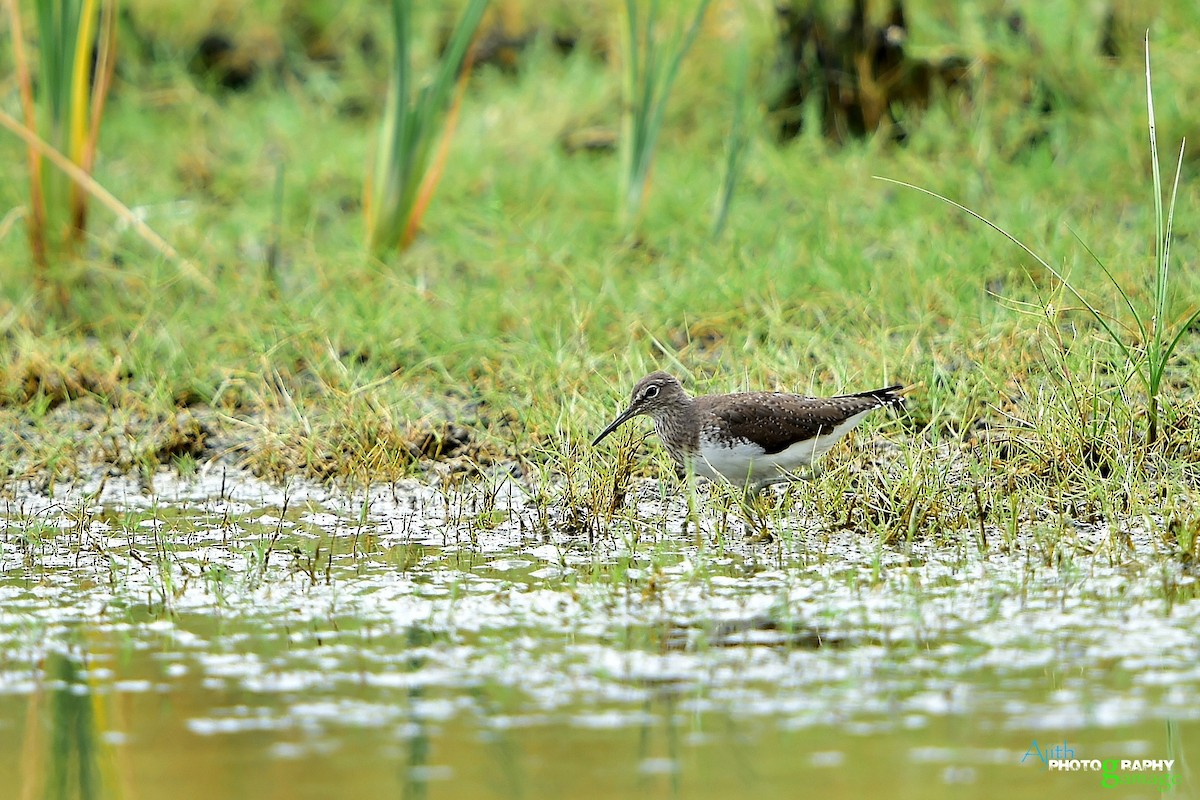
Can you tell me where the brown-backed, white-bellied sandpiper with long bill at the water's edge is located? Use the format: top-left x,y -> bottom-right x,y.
592,372 -> 904,492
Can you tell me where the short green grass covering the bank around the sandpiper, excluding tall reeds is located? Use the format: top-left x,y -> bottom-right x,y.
0,2 -> 1200,541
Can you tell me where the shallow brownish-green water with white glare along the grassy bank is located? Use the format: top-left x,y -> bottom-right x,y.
0,474 -> 1200,800
